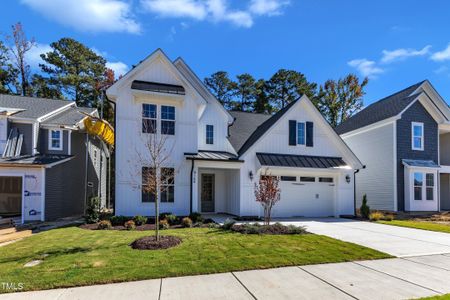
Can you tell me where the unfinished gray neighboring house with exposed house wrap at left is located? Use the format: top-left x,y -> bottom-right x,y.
0,95 -> 107,222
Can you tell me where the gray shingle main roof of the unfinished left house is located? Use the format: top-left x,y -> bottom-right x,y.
0,94 -> 73,119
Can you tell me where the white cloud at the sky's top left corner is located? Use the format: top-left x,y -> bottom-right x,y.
22,0 -> 141,34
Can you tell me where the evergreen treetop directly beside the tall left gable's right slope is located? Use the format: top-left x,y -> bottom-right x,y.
204,71 -> 235,109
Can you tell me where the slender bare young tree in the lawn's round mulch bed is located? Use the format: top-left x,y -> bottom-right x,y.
131,119 -> 176,241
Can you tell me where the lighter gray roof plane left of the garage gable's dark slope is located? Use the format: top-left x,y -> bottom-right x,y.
228,111 -> 272,151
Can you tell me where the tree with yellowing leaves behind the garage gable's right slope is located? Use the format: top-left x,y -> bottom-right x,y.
316,74 -> 369,127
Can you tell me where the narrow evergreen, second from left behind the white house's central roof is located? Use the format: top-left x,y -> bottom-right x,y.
233,73 -> 256,111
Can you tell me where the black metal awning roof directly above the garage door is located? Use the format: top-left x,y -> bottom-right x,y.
256,153 -> 347,169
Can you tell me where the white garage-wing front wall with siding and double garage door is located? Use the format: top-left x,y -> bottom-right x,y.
240,100 -> 354,217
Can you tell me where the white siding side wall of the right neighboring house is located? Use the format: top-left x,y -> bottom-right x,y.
342,122 -> 397,211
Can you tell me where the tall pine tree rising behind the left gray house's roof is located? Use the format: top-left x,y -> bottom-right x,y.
40,38 -> 106,107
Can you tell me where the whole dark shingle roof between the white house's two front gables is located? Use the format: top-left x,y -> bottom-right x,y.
229,100 -> 298,156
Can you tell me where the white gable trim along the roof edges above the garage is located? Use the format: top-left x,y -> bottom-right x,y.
241,95 -> 363,169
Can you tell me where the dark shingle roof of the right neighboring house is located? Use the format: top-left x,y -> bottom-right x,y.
335,81 -> 425,134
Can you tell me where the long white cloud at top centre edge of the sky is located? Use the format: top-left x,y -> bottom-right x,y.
141,0 -> 289,28
